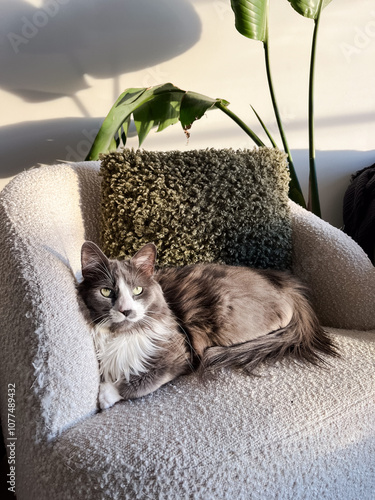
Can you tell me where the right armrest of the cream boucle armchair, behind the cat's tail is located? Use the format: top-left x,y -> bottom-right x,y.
290,202 -> 375,330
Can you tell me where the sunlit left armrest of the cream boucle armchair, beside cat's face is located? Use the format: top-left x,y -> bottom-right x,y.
0,164 -> 103,446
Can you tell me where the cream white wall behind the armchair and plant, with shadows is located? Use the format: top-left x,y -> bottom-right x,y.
0,0 -> 375,226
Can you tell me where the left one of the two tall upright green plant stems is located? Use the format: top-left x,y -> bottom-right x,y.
263,26 -> 306,208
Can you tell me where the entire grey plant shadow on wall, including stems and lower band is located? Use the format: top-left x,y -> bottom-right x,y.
0,0 -> 201,178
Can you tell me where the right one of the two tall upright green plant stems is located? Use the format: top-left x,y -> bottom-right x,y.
307,0 -> 323,217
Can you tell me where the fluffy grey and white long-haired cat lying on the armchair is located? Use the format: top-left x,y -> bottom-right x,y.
77,242 -> 335,409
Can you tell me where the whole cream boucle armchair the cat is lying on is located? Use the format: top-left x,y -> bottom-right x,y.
0,162 -> 375,500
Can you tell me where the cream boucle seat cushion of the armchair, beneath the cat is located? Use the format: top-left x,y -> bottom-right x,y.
54,329 -> 375,500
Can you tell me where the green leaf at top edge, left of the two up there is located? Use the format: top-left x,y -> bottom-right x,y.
230,0 -> 268,42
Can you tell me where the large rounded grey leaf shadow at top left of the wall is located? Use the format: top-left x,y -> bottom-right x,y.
0,0 -> 201,102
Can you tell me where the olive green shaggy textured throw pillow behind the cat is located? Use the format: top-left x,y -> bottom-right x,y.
101,148 -> 292,269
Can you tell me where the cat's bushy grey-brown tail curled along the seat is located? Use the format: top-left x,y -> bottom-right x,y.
201,287 -> 338,374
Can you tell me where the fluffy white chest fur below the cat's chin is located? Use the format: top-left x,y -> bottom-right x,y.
95,328 -> 168,383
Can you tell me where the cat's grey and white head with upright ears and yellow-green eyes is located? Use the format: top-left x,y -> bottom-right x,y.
77,241 -> 166,334
